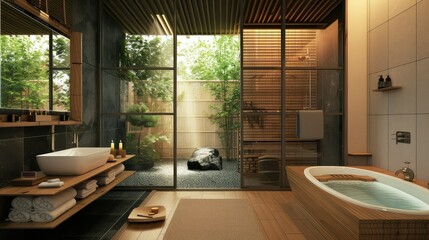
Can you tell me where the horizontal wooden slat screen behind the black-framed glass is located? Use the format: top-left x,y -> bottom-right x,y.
241,29 -> 318,173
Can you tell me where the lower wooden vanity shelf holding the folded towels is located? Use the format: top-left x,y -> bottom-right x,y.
0,171 -> 134,229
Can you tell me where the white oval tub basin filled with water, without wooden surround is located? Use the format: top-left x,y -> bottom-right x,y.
304,166 -> 429,215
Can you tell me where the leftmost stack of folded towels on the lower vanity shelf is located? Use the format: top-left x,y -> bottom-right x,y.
8,197 -> 33,222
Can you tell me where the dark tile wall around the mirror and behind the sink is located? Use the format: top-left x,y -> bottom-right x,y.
0,0 -> 122,187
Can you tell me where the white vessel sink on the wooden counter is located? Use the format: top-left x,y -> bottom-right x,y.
36,147 -> 110,175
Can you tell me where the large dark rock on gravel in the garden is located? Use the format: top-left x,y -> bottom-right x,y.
188,148 -> 222,170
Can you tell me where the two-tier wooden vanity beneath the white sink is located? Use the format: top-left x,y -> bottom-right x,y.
0,155 -> 134,229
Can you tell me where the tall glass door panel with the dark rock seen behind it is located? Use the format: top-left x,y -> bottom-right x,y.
176,0 -> 240,189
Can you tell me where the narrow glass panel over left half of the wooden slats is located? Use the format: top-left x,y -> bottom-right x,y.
241,28 -> 282,188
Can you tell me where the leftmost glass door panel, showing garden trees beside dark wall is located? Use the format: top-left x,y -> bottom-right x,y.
103,0 -> 176,188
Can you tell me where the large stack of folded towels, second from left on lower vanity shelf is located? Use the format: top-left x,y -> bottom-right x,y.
31,188 -> 77,222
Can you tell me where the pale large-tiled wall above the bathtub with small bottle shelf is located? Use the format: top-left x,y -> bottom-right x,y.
367,0 -> 429,181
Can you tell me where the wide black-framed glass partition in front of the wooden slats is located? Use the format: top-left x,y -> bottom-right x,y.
240,0 -> 344,189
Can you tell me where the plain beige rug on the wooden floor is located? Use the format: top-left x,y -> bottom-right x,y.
164,199 -> 266,240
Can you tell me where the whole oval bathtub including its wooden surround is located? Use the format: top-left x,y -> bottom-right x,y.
286,166 -> 429,239
